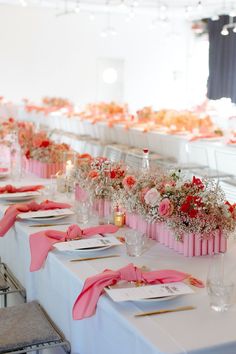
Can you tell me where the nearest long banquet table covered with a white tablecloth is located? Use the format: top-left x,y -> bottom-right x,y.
0,179 -> 236,354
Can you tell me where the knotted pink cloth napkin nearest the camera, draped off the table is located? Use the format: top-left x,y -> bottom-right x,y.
73,263 -> 189,320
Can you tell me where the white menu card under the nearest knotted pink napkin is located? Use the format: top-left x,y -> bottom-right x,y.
105,282 -> 194,302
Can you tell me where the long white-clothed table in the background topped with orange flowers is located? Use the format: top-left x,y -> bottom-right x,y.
17,107 -> 236,175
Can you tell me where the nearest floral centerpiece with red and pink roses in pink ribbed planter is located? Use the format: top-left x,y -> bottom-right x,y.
117,171 -> 236,256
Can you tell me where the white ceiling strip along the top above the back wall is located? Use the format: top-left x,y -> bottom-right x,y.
0,0 -> 236,20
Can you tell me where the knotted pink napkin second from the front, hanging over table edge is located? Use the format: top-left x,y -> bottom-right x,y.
30,225 -> 119,272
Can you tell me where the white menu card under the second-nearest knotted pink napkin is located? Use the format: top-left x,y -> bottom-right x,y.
54,235 -> 122,251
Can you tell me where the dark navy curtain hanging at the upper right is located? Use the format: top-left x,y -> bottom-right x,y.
207,15 -> 236,103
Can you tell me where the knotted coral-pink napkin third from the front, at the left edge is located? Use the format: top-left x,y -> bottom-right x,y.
0,200 -> 71,237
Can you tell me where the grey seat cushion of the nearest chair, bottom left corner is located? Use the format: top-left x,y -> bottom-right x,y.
0,301 -> 61,353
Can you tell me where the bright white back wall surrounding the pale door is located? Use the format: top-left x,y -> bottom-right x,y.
0,6 -> 207,108
